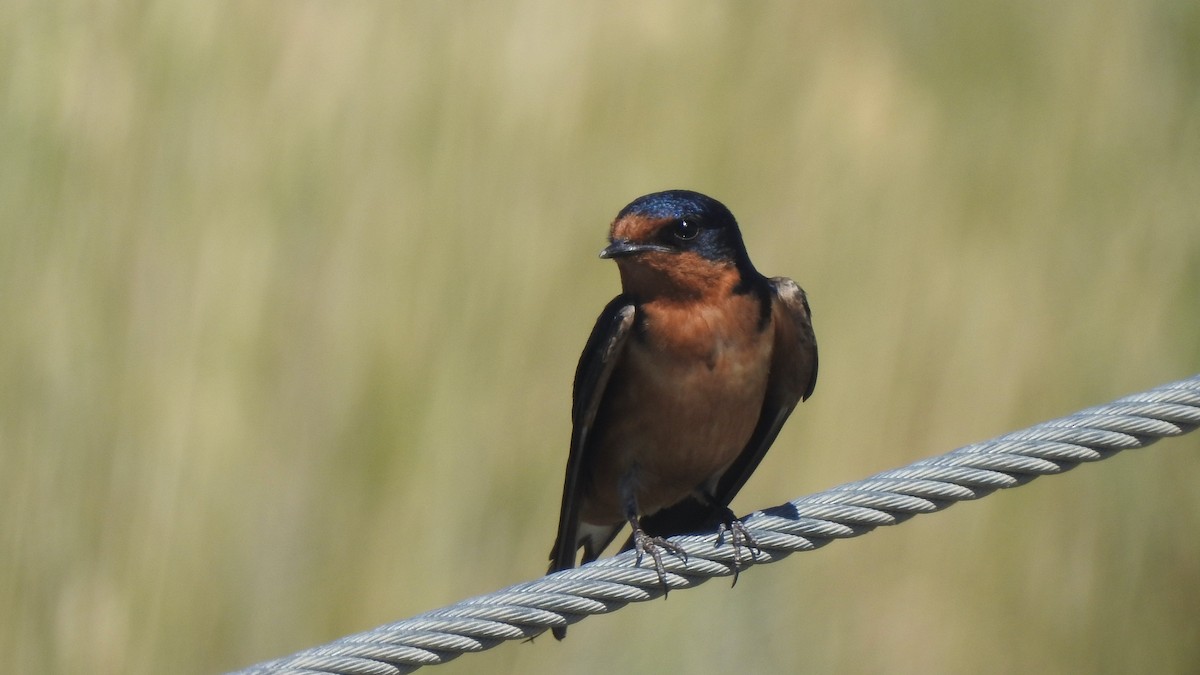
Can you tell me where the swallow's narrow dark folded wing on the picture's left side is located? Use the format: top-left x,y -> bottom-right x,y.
550,295 -> 635,572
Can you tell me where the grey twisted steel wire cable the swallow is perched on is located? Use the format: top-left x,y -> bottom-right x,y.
231,375 -> 1200,675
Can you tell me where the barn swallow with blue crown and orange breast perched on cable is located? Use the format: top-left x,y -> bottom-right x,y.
550,190 -> 817,639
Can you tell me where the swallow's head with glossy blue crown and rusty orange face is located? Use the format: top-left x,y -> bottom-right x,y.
600,190 -> 758,298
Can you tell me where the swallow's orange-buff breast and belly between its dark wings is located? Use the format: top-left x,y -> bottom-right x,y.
581,295 -> 774,524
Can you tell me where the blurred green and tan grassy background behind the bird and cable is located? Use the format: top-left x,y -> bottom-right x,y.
0,0 -> 1200,674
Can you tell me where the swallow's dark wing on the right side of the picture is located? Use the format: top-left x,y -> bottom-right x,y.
624,276 -> 817,535
